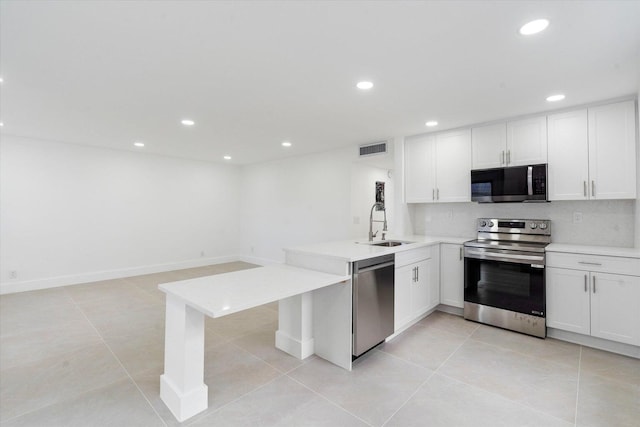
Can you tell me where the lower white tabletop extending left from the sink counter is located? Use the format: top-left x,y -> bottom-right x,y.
158,264 -> 351,317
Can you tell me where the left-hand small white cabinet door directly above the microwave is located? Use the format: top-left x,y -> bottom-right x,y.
471,123 -> 507,169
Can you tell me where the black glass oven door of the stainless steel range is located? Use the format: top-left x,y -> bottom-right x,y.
464,248 -> 545,317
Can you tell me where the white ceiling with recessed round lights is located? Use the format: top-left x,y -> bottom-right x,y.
0,0 -> 640,164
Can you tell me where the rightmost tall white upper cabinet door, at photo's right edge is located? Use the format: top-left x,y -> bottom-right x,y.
589,101 -> 636,199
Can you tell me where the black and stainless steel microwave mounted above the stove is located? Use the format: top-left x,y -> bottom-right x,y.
471,164 -> 547,203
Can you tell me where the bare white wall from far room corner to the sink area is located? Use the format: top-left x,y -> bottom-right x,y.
240,149 -> 354,263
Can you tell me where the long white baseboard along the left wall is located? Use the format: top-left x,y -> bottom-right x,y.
0,255 -> 240,295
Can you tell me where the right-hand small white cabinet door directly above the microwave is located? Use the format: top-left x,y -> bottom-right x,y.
507,116 -> 547,166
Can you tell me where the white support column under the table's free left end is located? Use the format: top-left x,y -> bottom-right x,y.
160,294 -> 208,422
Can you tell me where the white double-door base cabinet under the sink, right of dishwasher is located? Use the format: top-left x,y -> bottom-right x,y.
394,246 -> 440,331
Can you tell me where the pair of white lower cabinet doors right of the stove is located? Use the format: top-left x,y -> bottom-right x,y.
546,257 -> 640,345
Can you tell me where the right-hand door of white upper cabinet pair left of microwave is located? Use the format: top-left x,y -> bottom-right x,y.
436,129 -> 471,202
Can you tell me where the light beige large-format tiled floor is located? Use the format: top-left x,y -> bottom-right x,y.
0,262 -> 640,427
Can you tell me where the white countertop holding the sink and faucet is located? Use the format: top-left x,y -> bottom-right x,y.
284,235 -> 473,262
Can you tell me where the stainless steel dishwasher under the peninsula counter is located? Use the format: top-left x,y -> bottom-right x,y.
353,254 -> 395,357
